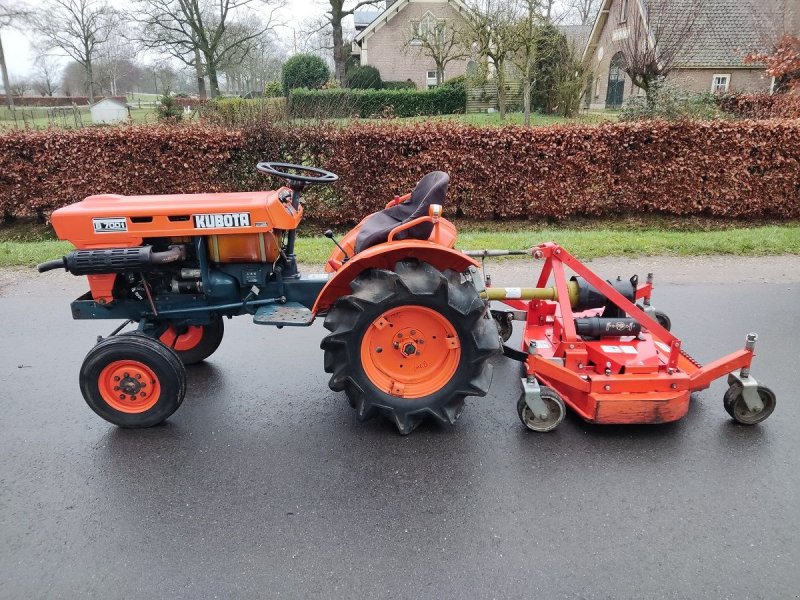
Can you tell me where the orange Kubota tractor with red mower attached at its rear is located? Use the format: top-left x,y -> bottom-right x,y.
38,163 -> 775,434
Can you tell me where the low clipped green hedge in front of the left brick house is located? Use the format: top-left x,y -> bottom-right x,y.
289,85 -> 467,119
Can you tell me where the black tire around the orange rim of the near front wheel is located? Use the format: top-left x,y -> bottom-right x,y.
79,332 -> 186,429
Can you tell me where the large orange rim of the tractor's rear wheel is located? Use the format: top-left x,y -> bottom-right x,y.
361,305 -> 461,399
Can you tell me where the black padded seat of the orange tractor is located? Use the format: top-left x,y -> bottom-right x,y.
355,171 -> 450,254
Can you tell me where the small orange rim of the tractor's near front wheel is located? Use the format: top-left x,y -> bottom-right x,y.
97,360 -> 161,414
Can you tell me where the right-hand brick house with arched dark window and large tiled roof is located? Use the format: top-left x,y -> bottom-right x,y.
582,0 -> 800,109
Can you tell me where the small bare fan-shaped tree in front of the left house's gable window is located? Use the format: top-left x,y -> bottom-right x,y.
404,14 -> 470,85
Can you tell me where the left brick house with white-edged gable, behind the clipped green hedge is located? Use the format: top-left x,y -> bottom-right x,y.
353,0 -> 468,90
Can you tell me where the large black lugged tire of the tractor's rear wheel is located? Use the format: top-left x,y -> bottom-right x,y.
321,259 -> 501,435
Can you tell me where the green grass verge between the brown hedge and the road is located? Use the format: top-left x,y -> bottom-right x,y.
0,223 -> 800,267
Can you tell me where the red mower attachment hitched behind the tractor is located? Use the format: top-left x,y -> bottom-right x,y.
487,243 -> 764,424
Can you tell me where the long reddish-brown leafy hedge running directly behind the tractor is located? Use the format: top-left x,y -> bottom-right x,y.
0,120 -> 800,225
